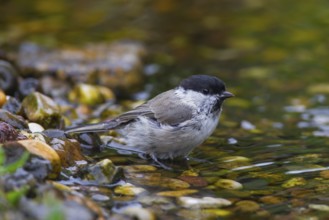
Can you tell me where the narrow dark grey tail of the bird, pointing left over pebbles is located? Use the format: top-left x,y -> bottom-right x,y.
65,120 -> 118,134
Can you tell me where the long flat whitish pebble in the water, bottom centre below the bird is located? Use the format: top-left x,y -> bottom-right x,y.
177,196 -> 232,209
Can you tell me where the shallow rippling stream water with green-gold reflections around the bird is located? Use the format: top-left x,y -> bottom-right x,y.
0,0 -> 329,219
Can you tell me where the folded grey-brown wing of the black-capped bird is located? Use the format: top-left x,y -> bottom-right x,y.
118,90 -> 193,125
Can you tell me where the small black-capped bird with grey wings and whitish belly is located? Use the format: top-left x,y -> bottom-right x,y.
65,75 -> 234,162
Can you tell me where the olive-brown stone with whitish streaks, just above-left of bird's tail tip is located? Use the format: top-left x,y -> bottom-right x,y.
22,92 -> 62,128
